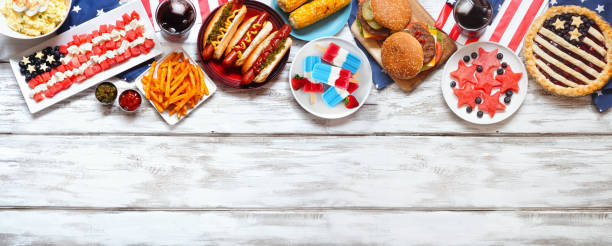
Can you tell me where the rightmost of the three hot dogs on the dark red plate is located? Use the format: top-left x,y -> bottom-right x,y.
242,24 -> 292,84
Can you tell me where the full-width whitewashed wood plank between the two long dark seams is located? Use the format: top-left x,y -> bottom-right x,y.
0,135 -> 612,208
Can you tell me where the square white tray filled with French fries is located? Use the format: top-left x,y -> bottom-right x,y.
136,48 -> 217,125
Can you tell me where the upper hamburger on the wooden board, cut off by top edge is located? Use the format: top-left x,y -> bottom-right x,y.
357,0 -> 412,40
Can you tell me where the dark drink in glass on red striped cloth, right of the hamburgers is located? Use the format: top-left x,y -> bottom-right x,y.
453,0 -> 493,38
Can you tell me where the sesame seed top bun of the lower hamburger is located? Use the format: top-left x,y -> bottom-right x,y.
381,32 -> 423,79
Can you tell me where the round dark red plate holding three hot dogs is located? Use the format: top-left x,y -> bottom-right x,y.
198,0 -> 292,89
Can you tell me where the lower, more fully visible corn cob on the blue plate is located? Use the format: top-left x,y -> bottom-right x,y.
289,0 -> 351,29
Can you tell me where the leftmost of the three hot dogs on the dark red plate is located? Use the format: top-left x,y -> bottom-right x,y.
202,0 -> 247,60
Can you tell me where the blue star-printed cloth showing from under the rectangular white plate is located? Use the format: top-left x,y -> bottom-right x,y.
58,0 -> 153,82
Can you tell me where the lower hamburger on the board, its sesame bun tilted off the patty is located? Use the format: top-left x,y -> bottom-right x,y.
381,22 -> 443,79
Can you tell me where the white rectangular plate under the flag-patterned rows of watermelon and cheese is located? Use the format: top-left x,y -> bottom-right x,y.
9,1 -> 161,114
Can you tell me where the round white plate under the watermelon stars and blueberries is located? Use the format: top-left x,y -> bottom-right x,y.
440,42 -> 528,124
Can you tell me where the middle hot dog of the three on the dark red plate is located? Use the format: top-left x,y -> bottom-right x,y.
222,12 -> 273,68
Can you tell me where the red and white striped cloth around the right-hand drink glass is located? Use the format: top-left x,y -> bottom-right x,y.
436,0 -> 548,52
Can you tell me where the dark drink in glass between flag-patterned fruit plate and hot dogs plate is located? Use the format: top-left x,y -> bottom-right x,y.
155,0 -> 196,41
